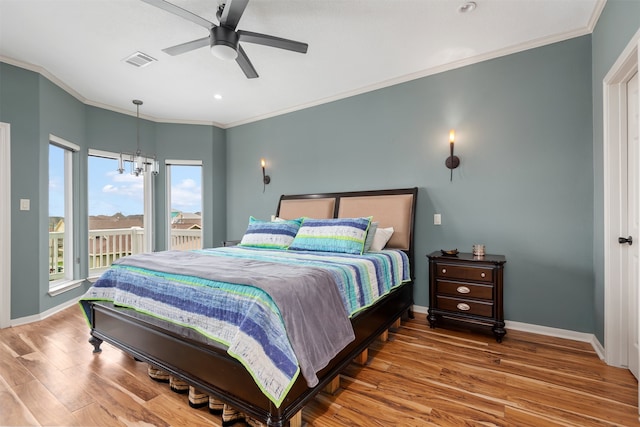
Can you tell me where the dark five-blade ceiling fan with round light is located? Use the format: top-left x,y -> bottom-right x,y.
142,0 -> 309,79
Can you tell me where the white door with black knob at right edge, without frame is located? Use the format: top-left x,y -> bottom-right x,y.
626,73 -> 640,378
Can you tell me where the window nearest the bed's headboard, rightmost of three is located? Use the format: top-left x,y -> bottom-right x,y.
166,160 -> 202,250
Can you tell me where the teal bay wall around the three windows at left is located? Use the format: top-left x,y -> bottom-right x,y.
0,63 -> 226,319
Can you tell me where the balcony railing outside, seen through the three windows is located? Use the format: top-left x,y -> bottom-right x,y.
49,227 -> 202,281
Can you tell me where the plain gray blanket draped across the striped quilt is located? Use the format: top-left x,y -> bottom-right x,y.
114,251 -> 355,387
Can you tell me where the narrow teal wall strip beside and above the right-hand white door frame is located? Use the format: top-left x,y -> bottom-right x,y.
592,0 -> 640,344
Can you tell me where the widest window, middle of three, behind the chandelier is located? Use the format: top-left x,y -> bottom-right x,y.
87,149 -> 153,277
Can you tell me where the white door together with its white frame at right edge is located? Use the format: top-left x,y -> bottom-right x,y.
602,36 -> 640,410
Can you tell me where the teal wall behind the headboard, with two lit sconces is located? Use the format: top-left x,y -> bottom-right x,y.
227,36 -> 594,332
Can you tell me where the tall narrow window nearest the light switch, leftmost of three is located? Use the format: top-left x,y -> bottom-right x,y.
48,135 -> 79,291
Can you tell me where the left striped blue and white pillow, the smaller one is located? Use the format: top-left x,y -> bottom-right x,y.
240,217 -> 302,249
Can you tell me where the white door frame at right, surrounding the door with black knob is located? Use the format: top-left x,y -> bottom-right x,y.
602,30 -> 640,367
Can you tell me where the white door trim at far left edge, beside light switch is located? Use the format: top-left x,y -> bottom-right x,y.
0,122 -> 11,328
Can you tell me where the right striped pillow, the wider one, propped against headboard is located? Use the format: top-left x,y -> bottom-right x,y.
289,217 -> 371,255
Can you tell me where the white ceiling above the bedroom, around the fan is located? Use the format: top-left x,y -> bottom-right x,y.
0,0 -> 605,127
